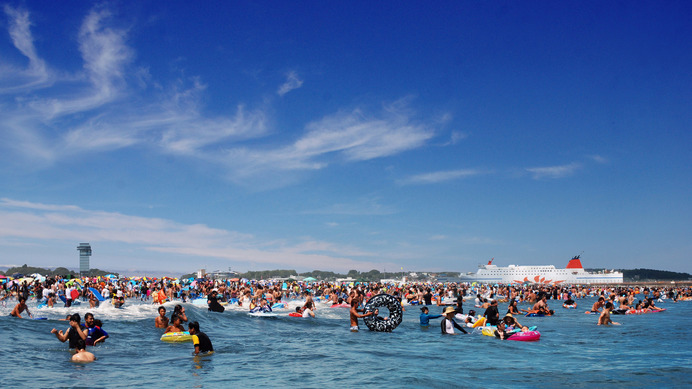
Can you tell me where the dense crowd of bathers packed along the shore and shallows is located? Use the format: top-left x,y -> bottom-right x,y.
0,277 -> 692,362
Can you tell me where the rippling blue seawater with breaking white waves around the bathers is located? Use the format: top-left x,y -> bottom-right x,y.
0,298 -> 692,388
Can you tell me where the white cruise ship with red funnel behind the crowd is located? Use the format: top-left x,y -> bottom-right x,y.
459,255 -> 622,285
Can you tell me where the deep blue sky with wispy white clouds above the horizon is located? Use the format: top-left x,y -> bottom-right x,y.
0,1 -> 692,274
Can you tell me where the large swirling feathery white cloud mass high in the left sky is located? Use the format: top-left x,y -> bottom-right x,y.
0,7 -> 440,186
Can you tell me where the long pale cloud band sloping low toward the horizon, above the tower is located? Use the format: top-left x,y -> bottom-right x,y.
0,198 -> 393,271
